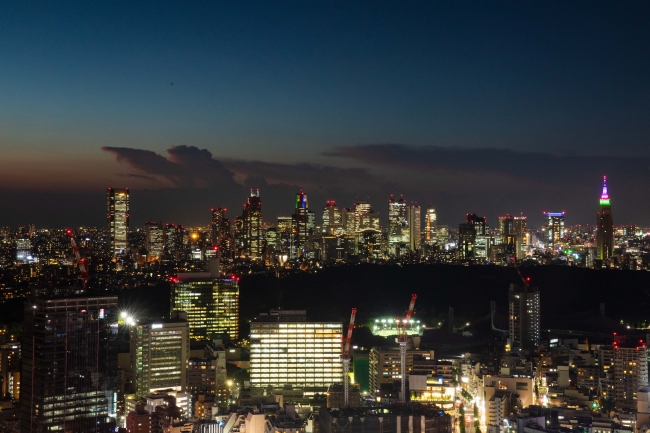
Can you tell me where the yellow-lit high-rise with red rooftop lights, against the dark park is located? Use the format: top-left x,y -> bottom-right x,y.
171,272 -> 239,340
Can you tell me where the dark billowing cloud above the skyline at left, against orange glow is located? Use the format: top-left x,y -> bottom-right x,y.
102,146 -> 235,187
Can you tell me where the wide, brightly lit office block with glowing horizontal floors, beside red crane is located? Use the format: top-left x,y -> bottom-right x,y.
250,310 -> 343,392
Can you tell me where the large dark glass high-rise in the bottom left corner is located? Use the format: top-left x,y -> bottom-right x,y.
20,296 -> 117,433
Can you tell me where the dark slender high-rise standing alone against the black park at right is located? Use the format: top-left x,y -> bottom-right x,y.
508,282 -> 541,350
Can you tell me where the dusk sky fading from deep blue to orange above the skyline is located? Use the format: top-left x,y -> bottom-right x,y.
0,1 -> 650,227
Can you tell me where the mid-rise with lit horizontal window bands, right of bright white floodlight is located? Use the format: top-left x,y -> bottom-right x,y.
130,314 -> 190,398
